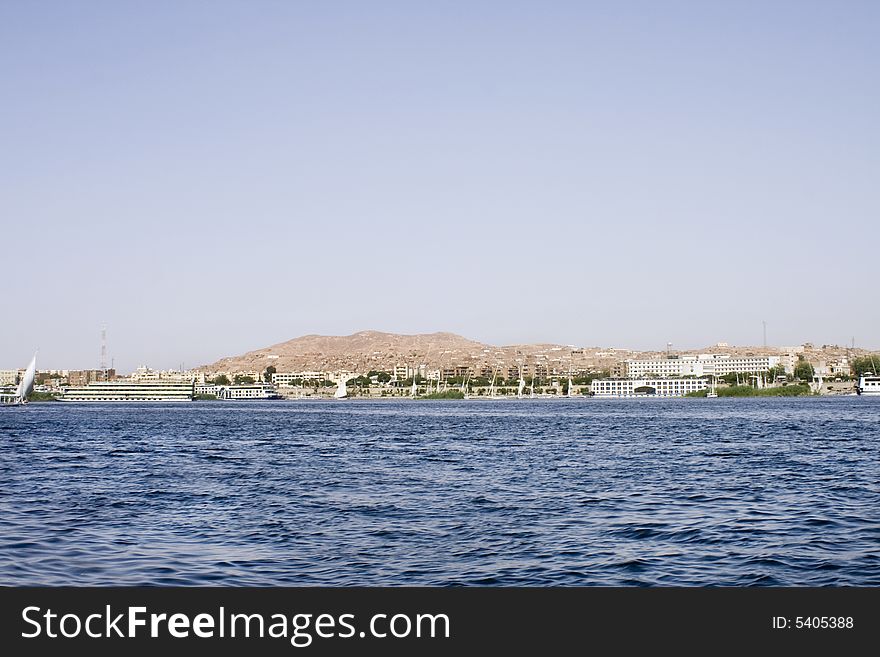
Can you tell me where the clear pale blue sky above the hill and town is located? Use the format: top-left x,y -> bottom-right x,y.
0,0 -> 880,370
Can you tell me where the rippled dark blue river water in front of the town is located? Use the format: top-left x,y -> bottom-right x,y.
0,397 -> 880,586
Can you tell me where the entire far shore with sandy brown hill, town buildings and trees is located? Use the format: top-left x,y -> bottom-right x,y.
0,331 -> 880,401
